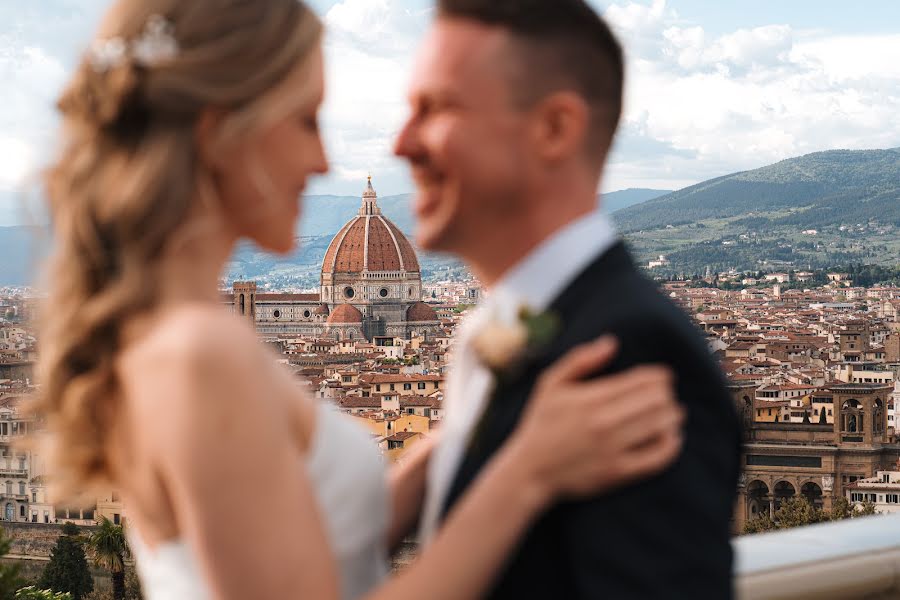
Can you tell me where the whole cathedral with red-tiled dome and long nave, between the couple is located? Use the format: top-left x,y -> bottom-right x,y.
225,177 -> 440,340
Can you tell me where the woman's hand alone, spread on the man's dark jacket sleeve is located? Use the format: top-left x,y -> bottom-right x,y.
510,337 -> 685,502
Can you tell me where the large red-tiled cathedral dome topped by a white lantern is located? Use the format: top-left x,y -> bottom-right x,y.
322,177 -> 419,273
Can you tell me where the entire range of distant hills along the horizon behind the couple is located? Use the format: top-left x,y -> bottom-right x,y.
0,148 -> 900,287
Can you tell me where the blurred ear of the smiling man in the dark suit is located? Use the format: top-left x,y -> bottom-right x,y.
532,90 -> 591,162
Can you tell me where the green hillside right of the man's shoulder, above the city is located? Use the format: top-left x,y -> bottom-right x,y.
613,148 -> 900,275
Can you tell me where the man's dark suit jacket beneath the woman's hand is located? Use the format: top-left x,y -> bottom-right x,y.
444,243 -> 740,600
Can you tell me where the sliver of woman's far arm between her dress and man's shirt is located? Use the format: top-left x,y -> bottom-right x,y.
388,432 -> 439,550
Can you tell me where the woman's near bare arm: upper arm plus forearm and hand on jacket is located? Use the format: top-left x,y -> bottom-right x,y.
158,319 -> 677,600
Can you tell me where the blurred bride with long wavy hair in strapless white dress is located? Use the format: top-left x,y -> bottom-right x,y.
35,0 -> 681,600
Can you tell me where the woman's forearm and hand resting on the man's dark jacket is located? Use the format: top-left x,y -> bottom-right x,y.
366,340 -> 684,600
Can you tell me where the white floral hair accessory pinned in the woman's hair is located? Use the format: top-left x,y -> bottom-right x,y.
88,15 -> 179,73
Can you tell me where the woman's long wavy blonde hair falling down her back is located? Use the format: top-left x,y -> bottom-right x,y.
38,0 -> 322,493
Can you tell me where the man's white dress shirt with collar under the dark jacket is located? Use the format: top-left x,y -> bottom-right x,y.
419,211 -> 617,543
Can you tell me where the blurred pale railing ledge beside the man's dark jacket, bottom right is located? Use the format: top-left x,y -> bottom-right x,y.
733,514 -> 900,600
